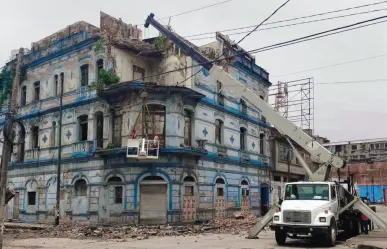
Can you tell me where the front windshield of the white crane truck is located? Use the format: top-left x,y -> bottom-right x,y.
285,184 -> 329,200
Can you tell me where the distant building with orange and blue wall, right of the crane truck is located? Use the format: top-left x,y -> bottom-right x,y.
324,138 -> 387,202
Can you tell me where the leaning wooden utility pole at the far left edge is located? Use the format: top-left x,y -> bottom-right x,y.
0,48 -> 24,249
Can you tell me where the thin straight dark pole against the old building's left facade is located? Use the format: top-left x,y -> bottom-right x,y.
54,79 -> 64,227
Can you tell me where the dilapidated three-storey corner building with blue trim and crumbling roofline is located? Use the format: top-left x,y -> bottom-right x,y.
0,13 -> 271,224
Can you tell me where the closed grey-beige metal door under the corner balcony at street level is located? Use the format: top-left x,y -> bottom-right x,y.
140,184 -> 167,224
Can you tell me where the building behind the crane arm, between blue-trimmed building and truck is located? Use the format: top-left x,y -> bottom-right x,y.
270,128 -> 329,203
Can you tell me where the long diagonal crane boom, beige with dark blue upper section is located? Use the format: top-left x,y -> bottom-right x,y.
145,13 -> 345,181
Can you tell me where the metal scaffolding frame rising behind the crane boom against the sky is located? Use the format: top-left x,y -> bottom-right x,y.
269,78 -> 314,132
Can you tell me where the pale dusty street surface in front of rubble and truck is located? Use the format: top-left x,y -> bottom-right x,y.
5,206 -> 387,249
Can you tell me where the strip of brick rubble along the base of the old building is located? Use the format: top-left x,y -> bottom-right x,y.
6,212 -> 266,240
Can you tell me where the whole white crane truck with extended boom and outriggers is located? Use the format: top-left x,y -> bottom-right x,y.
145,13 -> 387,246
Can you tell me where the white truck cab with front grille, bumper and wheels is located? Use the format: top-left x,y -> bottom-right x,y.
273,182 -> 339,246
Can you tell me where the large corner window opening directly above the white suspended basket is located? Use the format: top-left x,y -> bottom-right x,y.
146,105 -> 165,147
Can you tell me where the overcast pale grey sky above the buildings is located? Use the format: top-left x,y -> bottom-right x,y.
0,0 -> 387,141
